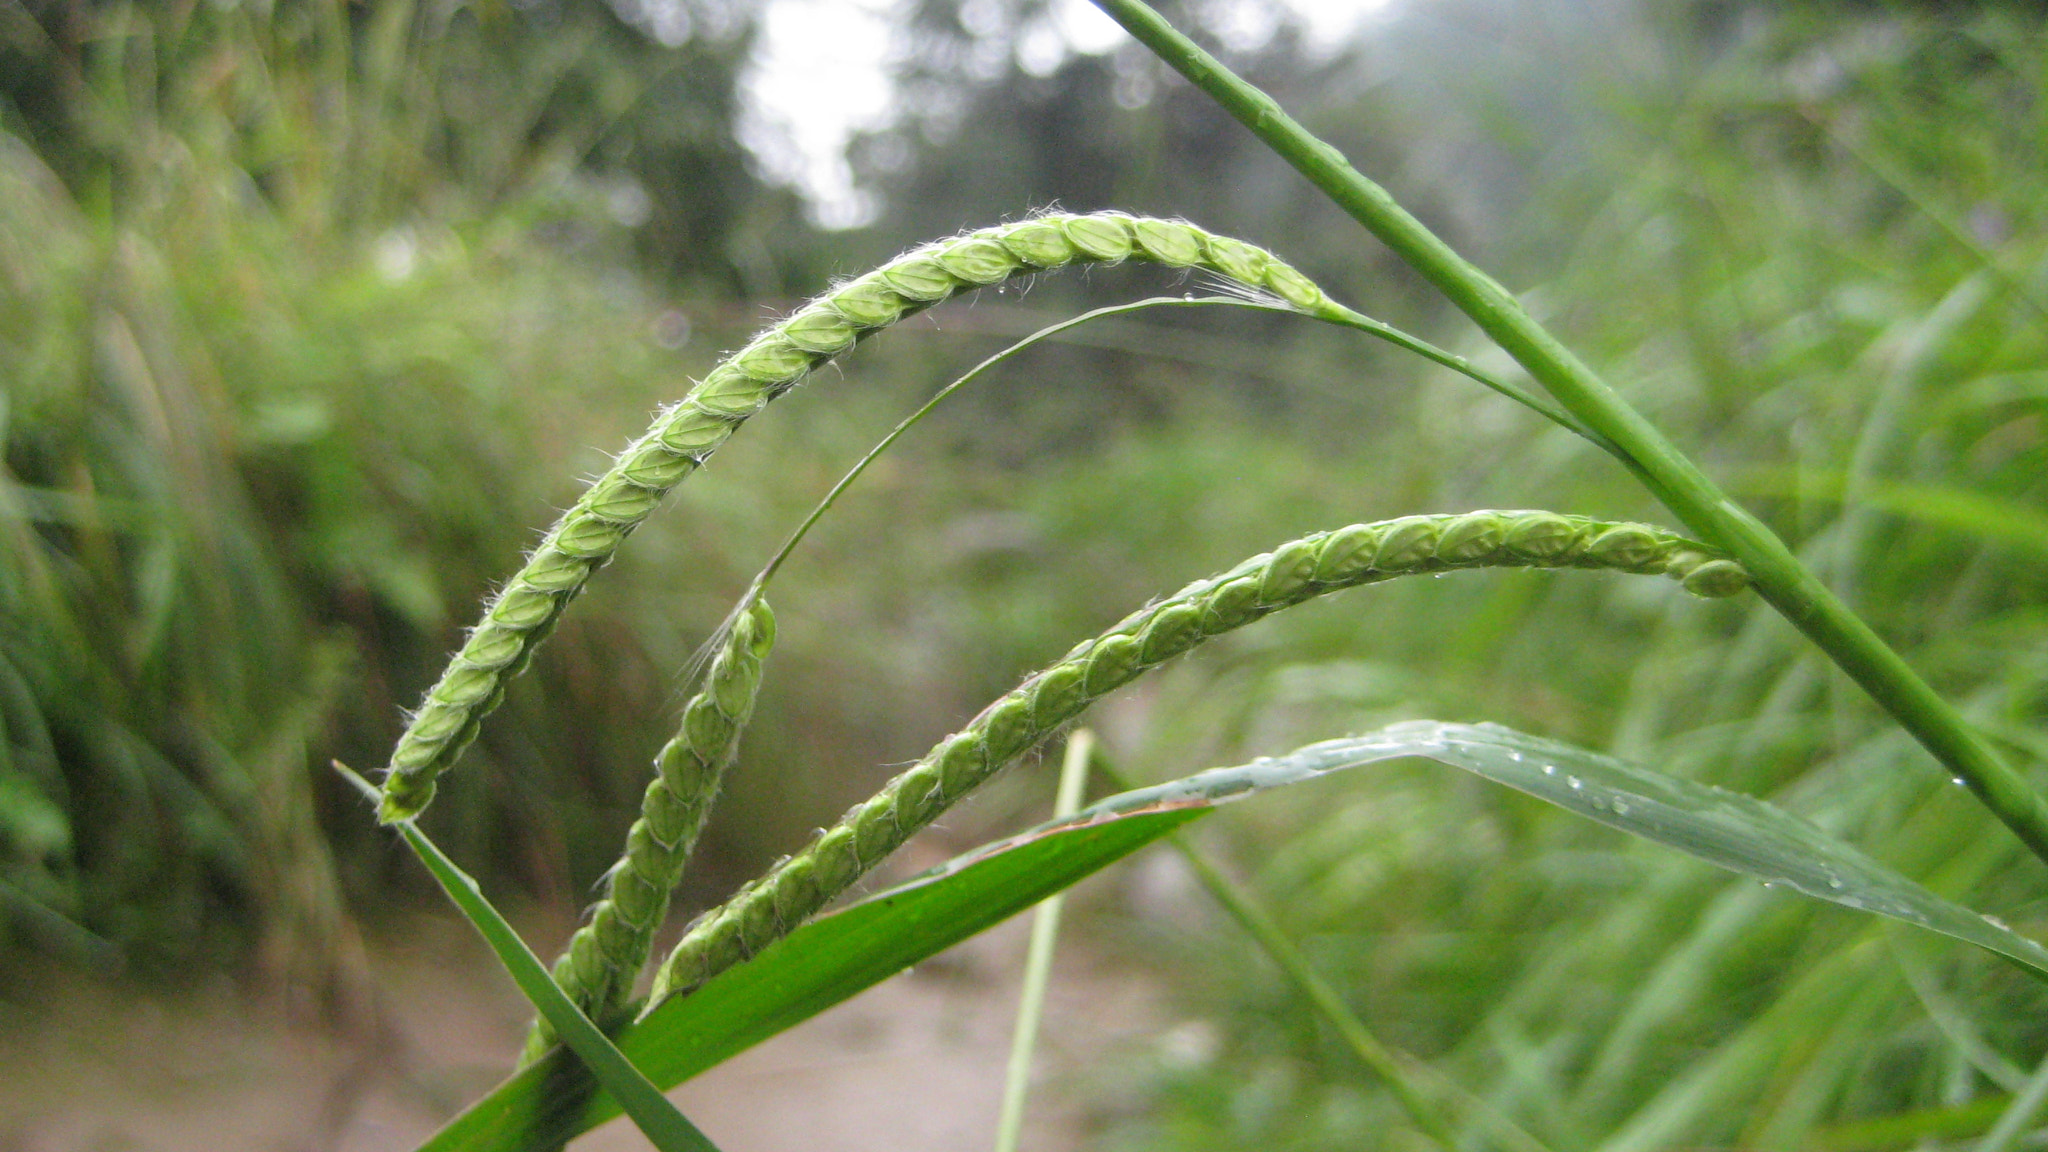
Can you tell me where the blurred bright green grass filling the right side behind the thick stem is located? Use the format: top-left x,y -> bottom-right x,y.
1081,4 -> 2048,1148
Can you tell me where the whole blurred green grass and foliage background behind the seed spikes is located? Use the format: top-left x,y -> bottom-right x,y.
0,0 -> 2048,1148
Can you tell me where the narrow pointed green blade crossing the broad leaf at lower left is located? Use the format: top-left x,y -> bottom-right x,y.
334,760 -> 719,1152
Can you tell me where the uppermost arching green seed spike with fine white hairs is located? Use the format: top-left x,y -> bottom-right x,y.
379,213 -> 1358,824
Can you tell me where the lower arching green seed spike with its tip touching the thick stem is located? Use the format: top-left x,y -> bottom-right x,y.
649,512 -> 1749,1009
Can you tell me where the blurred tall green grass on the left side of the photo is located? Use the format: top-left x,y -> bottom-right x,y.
0,4 -> 782,994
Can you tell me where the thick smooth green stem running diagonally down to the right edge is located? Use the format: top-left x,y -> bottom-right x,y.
1096,0 -> 2048,861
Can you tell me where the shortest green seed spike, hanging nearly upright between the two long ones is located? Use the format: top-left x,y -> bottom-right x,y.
520,601 -> 774,1066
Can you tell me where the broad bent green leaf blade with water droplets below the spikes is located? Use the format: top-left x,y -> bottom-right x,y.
426,722 -> 2048,1152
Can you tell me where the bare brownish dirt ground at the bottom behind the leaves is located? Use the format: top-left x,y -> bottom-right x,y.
0,897 -> 1165,1152
